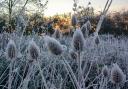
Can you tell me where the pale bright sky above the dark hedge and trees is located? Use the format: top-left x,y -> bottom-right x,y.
45,0 -> 128,16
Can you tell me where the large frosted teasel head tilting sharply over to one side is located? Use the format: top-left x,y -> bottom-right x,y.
45,36 -> 63,55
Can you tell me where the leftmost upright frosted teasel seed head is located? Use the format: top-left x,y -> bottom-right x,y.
6,40 -> 17,60
